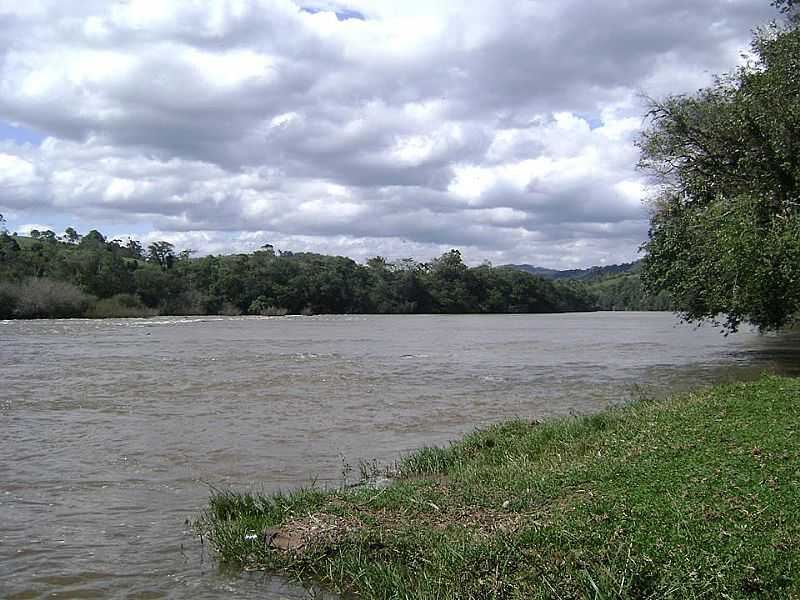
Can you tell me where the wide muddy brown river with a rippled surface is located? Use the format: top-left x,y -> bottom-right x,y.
0,313 -> 800,600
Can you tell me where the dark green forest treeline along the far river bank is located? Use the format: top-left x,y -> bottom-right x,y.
0,228 -> 669,319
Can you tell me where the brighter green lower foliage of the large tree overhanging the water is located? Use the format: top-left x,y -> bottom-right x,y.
645,196 -> 800,331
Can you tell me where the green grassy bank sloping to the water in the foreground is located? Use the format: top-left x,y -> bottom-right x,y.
198,376 -> 800,599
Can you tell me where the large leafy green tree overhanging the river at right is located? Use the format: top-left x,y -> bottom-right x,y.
639,0 -> 800,331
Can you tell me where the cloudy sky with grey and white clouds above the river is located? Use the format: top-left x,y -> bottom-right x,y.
0,0 -> 775,269
